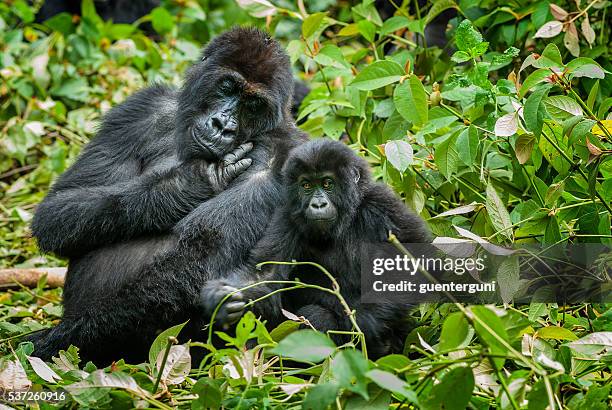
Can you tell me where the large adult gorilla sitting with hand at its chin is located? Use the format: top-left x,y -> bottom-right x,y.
32,28 -> 304,362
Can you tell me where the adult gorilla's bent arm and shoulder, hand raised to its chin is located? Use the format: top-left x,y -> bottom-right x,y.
32,87 -> 248,256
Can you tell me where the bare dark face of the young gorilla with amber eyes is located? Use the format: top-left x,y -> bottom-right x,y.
298,172 -> 338,230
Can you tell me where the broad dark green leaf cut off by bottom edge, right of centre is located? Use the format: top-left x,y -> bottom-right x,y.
422,366 -> 474,410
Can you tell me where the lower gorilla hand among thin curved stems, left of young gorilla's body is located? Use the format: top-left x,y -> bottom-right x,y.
199,281 -> 245,329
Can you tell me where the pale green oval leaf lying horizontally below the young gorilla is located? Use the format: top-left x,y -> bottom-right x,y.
272,329 -> 336,363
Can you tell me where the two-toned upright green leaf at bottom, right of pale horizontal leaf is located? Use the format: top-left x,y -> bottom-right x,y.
331,350 -> 369,400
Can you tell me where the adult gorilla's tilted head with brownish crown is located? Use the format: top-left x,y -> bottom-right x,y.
177,28 -> 293,160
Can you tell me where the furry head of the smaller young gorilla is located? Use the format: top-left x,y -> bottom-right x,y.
283,139 -> 371,241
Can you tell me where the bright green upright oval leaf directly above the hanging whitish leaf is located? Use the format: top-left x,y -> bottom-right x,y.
393,74 -> 428,126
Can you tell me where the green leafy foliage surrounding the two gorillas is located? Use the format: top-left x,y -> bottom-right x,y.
0,0 -> 612,409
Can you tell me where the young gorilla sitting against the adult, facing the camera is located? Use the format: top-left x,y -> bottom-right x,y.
203,139 -> 430,357
